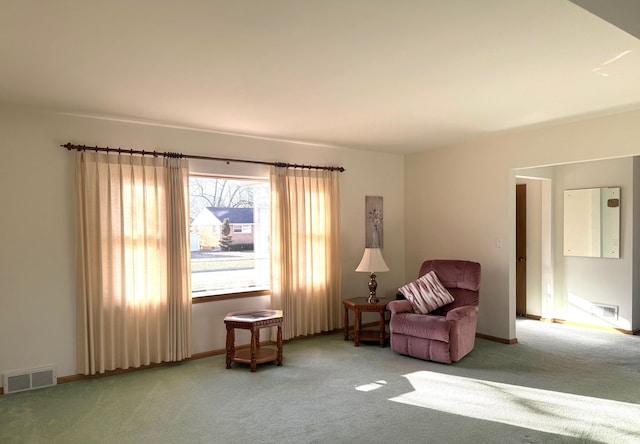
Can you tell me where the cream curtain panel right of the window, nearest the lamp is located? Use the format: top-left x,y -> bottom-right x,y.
271,167 -> 342,339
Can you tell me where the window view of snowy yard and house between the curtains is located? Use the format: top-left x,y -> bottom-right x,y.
189,175 -> 270,297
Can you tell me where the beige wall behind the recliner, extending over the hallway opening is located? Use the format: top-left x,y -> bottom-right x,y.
405,111 -> 640,339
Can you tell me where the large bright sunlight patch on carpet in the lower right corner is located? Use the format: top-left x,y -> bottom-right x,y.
390,371 -> 640,443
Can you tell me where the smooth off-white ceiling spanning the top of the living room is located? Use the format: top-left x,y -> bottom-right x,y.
0,0 -> 640,152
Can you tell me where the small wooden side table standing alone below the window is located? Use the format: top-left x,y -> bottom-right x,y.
224,310 -> 282,372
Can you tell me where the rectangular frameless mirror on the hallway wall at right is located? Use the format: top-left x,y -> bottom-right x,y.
564,187 -> 620,258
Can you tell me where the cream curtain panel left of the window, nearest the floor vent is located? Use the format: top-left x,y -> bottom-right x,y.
76,151 -> 191,374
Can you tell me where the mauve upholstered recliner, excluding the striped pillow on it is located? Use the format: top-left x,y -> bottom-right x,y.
387,260 -> 480,364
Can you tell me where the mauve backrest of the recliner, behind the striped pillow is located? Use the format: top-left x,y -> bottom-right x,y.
418,259 -> 481,314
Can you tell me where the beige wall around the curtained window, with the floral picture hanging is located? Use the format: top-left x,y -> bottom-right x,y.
0,105 -> 405,376
